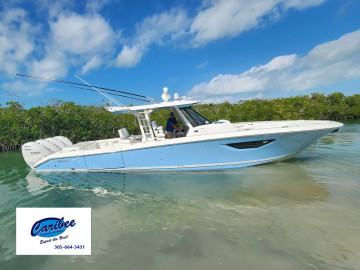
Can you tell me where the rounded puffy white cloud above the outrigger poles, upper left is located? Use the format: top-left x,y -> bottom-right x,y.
30,13 -> 116,78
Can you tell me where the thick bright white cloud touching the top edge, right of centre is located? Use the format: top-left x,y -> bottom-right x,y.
189,0 -> 325,47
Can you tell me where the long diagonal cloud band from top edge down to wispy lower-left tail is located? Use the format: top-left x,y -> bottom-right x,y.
115,0 -> 326,68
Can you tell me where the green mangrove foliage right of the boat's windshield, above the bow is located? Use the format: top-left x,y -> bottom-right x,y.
196,93 -> 360,122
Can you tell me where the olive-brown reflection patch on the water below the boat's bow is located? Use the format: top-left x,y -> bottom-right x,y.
227,162 -> 330,206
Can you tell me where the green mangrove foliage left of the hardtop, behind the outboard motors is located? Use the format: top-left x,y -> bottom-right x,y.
0,100 -> 140,151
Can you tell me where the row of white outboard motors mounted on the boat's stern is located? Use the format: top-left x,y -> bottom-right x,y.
21,136 -> 73,168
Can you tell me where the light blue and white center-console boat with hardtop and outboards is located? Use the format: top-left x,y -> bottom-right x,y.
22,88 -> 343,172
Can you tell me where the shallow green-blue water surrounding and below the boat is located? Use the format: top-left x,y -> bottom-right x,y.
0,121 -> 360,270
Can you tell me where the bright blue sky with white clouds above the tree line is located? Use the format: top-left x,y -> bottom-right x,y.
0,0 -> 360,108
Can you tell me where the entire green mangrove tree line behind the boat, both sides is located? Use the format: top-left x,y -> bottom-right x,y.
0,92 -> 360,151
